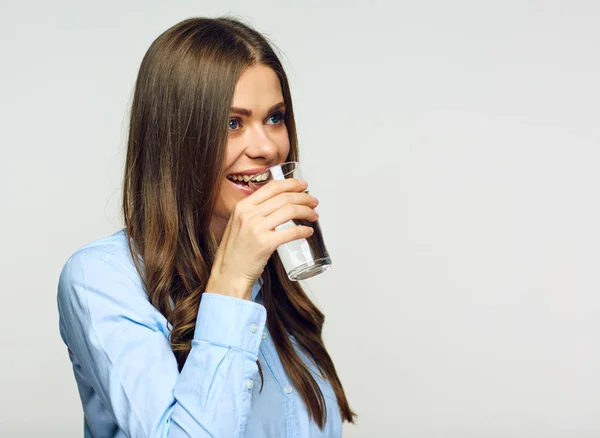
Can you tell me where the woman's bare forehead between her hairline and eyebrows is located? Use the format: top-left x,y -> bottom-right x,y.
232,65 -> 283,112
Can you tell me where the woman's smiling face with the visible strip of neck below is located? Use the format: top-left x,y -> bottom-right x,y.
211,65 -> 290,239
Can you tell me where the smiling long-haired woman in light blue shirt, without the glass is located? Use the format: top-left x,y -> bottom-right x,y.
58,18 -> 355,438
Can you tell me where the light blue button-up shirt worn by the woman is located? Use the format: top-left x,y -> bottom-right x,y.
58,230 -> 342,438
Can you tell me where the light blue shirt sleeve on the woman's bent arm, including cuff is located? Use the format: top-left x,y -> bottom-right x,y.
58,251 -> 266,438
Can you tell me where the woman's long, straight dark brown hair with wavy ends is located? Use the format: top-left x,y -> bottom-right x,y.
123,17 -> 355,427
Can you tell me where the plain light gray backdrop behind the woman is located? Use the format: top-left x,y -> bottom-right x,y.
0,0 -> 600,438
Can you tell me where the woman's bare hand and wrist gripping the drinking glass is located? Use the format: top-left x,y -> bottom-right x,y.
206,178 -> 319,299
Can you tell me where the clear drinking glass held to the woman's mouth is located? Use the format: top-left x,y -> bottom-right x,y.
248,161 -> 332,281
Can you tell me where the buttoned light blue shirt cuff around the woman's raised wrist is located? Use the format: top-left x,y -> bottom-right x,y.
194,292 -> 267,355
